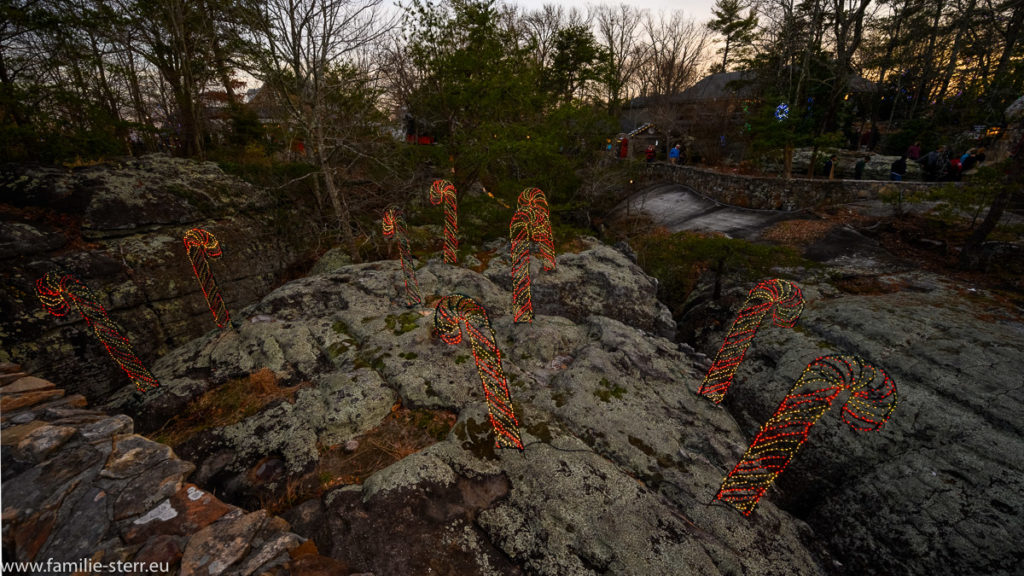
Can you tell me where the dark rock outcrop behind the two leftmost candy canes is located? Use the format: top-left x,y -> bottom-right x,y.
0,155 -> 312,401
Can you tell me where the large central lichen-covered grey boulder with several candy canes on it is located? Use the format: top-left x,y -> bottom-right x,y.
111,235 -> 823,575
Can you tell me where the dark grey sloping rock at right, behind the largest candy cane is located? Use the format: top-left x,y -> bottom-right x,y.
688,271 -> 1024,574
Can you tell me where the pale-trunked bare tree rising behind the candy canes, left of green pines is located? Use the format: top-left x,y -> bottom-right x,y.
243,0 -> 395,259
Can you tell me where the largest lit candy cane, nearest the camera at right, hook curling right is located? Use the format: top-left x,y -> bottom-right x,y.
715,356 -> 898,516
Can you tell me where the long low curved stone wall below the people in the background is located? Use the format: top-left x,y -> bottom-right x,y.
645,162 -> 936,210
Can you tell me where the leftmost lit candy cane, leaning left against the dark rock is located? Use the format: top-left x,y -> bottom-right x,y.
36,272 -> 160,392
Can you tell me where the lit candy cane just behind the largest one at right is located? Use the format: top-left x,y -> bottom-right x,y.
697,279 -> 804,404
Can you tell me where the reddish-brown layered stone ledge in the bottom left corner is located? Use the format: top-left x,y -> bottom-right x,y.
0,364 -> 348,576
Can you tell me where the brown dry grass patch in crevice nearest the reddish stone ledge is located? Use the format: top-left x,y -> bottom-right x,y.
152,368 -> 309,447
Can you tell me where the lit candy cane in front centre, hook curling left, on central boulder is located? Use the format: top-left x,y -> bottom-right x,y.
434,294 -> 523,452
